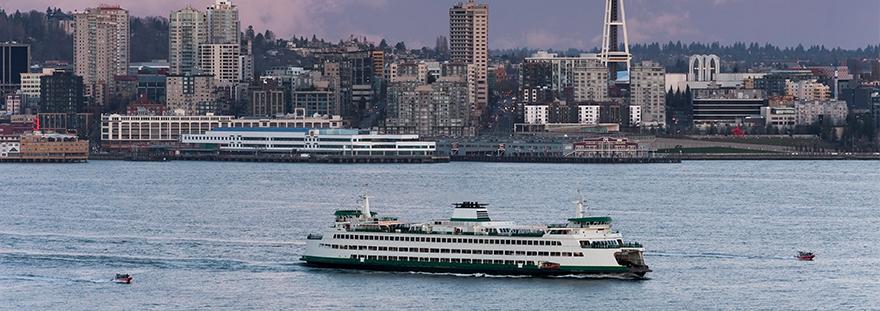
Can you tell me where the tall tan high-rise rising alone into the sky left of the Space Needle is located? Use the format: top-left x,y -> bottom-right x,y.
449,0 -> 489,125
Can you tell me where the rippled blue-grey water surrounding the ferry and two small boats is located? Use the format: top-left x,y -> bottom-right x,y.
0,161 -> 880,310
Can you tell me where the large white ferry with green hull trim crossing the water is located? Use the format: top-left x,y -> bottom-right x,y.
301,195 -> 651,277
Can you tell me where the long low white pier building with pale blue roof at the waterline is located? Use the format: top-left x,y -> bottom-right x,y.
181,128 -> 437,156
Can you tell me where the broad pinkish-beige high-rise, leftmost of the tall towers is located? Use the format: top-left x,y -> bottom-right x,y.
73,5 -> 130,106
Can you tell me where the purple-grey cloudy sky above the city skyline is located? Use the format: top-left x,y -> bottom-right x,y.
0,0 -> 880,49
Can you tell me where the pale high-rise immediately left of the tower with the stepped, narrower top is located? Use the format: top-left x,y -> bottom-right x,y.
168,6 -> 208,74
